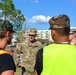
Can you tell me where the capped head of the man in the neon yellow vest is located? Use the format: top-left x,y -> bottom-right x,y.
49,14 -> 70,40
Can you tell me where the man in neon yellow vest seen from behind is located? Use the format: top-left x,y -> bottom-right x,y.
35,14 -> 76,75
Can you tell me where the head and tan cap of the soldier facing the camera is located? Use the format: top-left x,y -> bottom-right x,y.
28,28 -> 37,42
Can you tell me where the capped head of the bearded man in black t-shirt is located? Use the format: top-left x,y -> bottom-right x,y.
0,20 -> 15,44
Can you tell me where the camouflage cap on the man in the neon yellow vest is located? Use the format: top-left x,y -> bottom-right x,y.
49,14 -> 70,29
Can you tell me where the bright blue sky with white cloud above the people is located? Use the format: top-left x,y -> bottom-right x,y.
12,0 -> 76,30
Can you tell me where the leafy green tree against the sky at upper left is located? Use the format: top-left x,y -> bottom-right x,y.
0,0 -> 26,30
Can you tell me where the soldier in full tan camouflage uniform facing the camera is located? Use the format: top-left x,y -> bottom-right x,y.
18,28 -> 43,75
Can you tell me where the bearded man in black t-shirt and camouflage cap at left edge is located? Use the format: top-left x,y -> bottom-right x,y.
0,20 -> 16,75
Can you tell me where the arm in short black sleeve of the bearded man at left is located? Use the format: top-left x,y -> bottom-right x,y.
0,54 -> 16,75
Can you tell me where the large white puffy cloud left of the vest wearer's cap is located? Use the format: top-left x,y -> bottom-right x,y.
28,15 -> 51,24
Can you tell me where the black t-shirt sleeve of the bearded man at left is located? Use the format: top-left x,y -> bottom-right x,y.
0,54 -> 16,75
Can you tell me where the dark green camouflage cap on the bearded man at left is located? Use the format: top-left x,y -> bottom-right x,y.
0,20 -> 15,32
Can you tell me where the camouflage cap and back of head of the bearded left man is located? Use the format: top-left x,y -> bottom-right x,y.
0,20 -> 15,38
